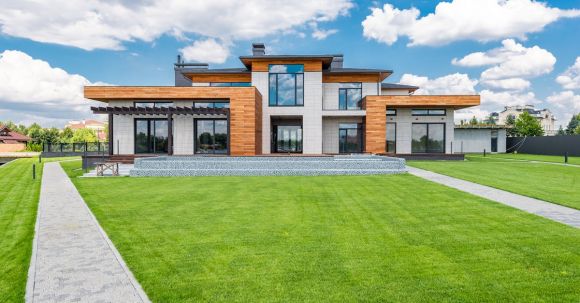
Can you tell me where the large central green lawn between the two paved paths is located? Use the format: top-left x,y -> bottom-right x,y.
63,162 -> 580,302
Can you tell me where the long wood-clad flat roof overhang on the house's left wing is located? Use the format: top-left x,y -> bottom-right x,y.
84,86 -> 261,102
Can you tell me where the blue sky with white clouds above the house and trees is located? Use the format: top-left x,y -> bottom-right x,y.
0,0 -> 580,127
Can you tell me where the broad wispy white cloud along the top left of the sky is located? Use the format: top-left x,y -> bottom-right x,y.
0,0 -> 353,50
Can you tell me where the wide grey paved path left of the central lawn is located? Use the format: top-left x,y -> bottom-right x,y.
26,163 -> 149,303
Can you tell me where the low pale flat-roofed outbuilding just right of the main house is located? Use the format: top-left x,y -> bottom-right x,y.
453,125 -> 507,153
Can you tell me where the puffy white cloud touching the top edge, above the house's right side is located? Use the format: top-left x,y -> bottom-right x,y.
362,0 -> 580,46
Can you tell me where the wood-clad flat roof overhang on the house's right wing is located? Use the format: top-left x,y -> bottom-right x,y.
363,95 -> 481,109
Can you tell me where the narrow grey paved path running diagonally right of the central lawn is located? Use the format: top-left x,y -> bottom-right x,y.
407,166 -> 580,228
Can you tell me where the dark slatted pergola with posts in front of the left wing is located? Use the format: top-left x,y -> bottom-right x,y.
91,106 -> 230,155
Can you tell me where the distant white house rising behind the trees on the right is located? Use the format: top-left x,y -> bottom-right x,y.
491,105 -> 558,136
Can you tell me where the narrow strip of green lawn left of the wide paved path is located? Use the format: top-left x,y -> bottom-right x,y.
0,159 -> 42,302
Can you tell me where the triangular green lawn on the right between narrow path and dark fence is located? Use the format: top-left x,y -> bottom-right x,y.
407,156 -> 580,209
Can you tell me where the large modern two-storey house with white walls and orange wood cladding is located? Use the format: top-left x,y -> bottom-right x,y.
84,44 -> 480,155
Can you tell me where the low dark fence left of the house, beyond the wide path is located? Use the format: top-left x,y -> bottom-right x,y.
42,142 -> 109,157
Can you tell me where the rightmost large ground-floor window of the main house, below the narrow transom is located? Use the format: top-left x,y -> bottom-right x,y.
411,123 -> 445,153
